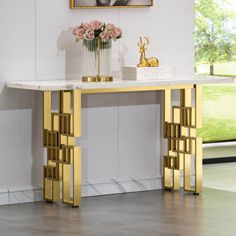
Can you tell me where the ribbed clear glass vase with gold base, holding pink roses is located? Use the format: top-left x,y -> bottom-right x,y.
82,39 -> 113,82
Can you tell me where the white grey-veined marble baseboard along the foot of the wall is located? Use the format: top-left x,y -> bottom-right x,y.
0,176 -> 162,205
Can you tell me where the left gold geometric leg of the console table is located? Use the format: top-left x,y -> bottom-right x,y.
43,90 -> 81,206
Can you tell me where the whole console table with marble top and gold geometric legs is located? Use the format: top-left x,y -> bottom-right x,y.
7,75 -> 233,206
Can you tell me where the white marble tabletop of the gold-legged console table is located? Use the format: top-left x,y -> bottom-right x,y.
6,75 -> 234,91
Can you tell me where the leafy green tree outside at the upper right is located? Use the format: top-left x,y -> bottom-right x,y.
195,0 -> 236,75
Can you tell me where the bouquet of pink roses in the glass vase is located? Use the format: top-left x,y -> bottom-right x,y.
73,20 -> 122,50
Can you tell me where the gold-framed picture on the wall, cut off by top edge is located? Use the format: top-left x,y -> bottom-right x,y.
70,0 -> 153,9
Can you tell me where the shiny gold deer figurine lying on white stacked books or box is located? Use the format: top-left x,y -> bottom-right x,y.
137,37 -> 159,67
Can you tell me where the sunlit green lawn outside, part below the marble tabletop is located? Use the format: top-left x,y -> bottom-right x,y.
199,84 -> 236,142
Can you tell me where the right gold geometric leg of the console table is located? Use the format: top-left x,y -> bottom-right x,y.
163,85 -> 202,194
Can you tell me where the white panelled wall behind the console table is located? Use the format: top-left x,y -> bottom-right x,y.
0,0 -> 194,202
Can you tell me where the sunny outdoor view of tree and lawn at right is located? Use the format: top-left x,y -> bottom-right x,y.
195,0 -> 236,142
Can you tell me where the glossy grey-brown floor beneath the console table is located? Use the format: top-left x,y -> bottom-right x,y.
0,163 -> 236,236
